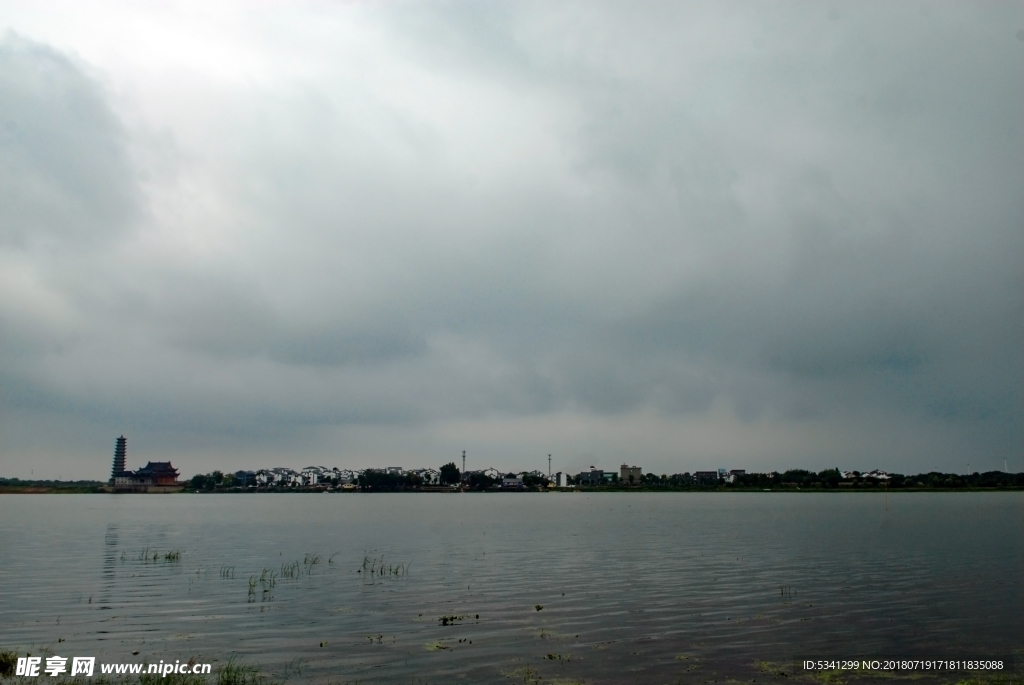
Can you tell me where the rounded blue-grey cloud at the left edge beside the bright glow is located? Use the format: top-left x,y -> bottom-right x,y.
0,34 -> 138,248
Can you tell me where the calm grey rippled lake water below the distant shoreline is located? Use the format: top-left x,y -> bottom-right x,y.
0,493 -> 1024,683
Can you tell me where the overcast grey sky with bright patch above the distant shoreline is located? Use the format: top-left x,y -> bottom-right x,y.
0,0 -> 1024,479
